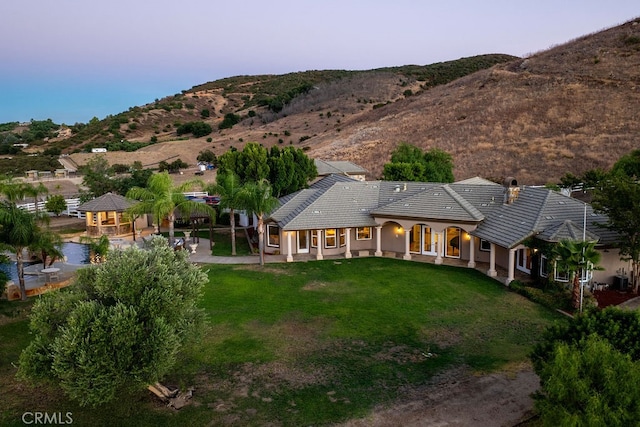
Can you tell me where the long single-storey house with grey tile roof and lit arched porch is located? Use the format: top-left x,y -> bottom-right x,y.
265,174 -> 629,284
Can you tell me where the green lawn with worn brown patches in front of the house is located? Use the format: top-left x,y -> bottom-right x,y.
0,258 -> 557,426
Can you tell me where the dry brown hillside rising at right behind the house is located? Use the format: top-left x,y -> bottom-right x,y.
309,20 -> 640,184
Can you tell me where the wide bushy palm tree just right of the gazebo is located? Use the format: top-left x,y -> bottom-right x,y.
127,171 -> 215,246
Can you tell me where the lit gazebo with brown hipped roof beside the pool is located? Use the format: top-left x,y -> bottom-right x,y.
78,193 -> 142,236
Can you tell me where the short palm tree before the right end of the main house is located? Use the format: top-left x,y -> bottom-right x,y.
553,240 -> 600,309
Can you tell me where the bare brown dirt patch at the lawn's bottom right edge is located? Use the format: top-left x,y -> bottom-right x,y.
341,366 -> 540,427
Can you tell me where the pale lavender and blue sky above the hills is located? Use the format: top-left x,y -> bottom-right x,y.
0,0 -> 640,125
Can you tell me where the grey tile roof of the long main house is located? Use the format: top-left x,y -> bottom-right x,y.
270,175 -> 615,248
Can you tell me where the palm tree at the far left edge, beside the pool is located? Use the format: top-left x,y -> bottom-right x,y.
0,200 -> 40,301
